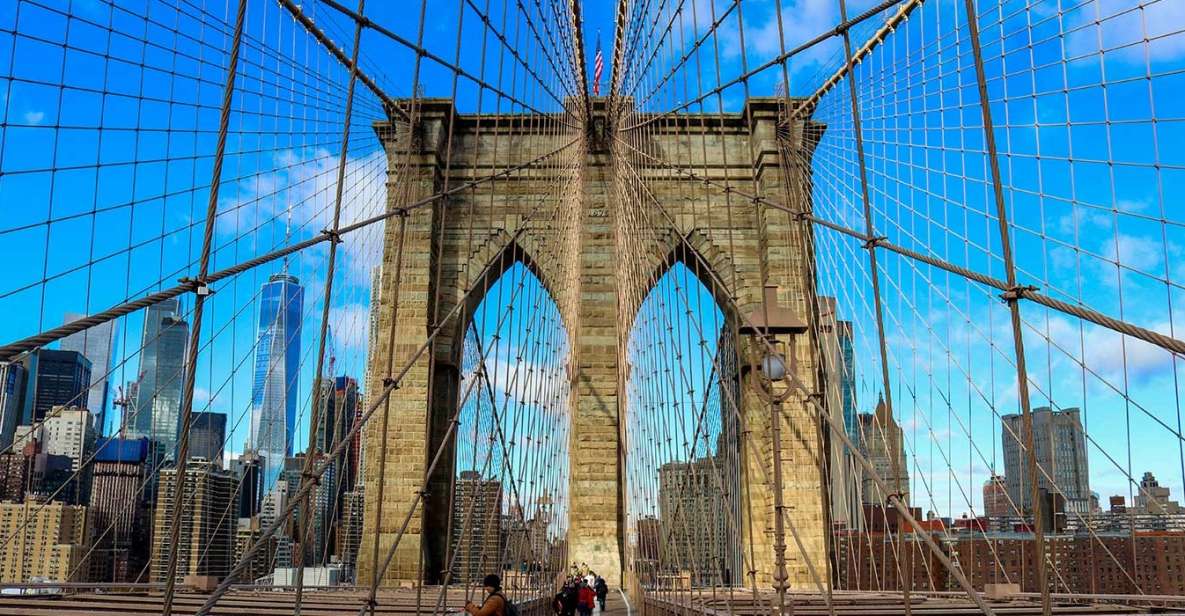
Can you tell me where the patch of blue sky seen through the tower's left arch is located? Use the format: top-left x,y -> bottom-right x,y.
455,262 -> 570,537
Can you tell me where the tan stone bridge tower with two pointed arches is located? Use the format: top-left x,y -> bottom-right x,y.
358,98 -> 827,589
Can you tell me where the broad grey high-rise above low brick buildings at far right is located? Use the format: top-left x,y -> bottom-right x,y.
1000,406 -> 1090,513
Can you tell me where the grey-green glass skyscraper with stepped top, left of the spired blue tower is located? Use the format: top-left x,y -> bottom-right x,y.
124,300 -> 190,458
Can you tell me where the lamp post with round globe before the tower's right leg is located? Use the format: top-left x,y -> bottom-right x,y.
738,284 -> 807,614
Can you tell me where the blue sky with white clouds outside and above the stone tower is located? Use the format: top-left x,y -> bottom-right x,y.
0,0 -> 1185,523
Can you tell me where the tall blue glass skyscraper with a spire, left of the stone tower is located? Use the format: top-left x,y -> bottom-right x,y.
251,272 -> 305,492
